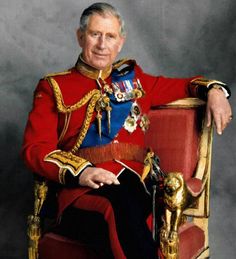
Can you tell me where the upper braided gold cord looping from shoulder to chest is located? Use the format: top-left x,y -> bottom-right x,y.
47,77 -> 100,113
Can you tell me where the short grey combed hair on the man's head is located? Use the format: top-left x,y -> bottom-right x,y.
80,3 -> 126,36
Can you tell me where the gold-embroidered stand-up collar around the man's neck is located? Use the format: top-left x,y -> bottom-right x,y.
75,55 -> 112,80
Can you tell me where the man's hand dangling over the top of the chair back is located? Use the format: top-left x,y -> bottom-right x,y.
206,88 -> 233,135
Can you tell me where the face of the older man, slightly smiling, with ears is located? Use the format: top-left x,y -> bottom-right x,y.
77,14 -> 125,70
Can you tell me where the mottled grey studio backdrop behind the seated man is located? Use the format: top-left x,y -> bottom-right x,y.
0,0 -> 236,259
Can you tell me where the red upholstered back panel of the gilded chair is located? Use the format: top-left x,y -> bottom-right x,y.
145,102 -> 202,180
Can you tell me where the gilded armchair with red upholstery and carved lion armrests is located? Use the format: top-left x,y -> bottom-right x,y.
28,98 -> 212,259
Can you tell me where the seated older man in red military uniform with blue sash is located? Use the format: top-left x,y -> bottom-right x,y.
22,3 -> 232,259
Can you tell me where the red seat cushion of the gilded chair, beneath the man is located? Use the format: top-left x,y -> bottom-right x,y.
39,223 -> 204,259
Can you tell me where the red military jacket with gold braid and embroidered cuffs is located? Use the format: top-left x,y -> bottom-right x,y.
22,57 -> 195,215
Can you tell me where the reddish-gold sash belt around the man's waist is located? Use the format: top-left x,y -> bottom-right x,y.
76,143 -> 147,164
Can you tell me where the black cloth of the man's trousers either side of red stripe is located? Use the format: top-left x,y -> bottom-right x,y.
54,170 -> 157,259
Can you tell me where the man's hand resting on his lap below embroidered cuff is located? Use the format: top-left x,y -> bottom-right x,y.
79,167 -> 120,189
